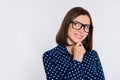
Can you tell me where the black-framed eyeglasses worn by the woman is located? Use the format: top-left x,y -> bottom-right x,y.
71,21 -> 90,33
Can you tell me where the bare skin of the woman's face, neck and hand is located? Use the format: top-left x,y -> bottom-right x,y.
66,15 -> 90,62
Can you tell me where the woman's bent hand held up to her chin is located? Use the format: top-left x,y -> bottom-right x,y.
73,42 -> 86,62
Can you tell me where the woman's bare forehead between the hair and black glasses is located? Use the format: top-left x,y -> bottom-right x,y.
74,15 -> 90,24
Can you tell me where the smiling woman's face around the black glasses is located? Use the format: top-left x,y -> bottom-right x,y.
67,15 -> 90,45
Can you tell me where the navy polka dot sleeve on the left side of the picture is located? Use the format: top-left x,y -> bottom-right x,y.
43,52 -> 66,80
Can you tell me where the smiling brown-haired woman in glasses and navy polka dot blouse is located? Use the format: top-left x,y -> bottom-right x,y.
43,7 -> 105,80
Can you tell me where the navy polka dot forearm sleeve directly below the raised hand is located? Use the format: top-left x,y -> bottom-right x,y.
64,60 -> 84,80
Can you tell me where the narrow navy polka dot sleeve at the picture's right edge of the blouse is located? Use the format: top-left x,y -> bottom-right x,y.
94,52 -> 105,80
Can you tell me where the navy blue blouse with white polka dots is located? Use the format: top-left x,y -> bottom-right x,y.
43,45 -> 105,80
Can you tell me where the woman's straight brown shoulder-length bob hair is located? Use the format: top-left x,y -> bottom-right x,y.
56,7 -> 93,52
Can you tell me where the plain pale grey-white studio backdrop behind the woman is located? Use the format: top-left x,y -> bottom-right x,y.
0,0 -> 120,80
